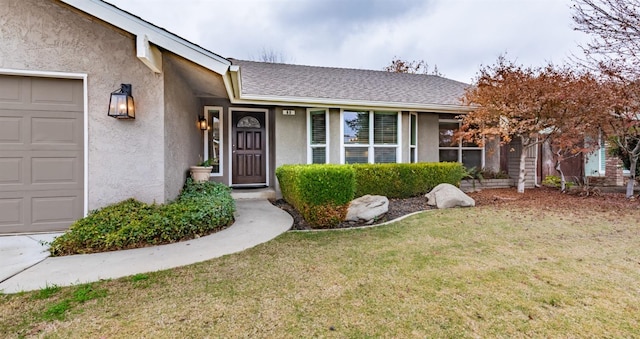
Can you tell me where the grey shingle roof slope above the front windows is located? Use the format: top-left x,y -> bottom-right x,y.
230,59 -> 469,105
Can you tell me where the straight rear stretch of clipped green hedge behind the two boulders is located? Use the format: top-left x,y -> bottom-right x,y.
352,162 -> 464,198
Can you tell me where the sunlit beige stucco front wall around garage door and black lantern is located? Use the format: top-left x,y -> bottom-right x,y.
0,0 -> 165,209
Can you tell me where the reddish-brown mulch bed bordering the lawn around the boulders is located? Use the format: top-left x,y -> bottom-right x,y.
271,187 -> 640,230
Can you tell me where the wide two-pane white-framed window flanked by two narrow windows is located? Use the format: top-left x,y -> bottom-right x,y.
340,110 -> 401,164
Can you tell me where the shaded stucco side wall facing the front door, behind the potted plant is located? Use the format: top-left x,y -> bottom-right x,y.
162,53 -> 202,200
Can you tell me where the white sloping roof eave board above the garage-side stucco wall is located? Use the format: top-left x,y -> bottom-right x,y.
61,0 -> 231,75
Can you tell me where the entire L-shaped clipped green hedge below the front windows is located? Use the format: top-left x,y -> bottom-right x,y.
276,163 -> 464,228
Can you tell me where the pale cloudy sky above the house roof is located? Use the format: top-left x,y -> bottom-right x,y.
107,0 -> 588,83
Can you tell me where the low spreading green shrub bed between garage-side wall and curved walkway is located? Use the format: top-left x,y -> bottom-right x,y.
49,178 -> 235,256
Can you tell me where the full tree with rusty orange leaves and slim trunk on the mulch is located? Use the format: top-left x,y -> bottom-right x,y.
458,56 -> 603,193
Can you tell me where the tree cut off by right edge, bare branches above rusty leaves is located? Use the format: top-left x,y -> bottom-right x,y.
573,0 -> 640,197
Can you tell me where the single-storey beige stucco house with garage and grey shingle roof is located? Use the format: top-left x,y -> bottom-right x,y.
0,0 -> 488,233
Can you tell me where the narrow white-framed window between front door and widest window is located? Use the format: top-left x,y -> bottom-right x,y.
307,108 -> 329,164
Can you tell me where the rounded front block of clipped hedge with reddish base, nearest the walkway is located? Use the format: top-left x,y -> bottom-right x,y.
276,165 -> 355,228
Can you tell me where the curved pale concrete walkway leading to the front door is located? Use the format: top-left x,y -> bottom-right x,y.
0,200 -> 293,293
